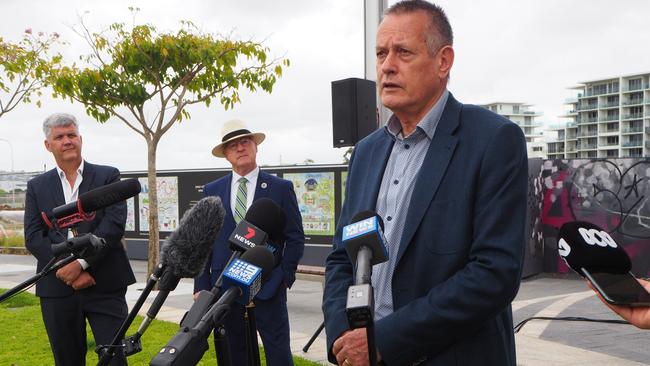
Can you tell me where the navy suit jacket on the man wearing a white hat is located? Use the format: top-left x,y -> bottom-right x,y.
194,171 -> 305,300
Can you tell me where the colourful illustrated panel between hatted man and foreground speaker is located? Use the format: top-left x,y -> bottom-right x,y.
283,172 -> 335,235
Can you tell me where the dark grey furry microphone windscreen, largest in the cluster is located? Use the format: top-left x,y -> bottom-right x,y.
160,196 -> 225,278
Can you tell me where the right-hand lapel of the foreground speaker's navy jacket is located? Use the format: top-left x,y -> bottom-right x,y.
397,94 -> 461,263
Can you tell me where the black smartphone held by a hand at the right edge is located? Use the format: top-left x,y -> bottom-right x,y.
582,268 -> 650,306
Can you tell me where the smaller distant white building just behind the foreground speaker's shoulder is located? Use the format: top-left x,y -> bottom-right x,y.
482,102 -> 546,158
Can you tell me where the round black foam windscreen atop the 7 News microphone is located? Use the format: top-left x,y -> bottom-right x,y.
244,198 -> 287,244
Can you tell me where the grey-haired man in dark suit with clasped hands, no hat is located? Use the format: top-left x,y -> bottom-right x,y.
25,113 -> 135,366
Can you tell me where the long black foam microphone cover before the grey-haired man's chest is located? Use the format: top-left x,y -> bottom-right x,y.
79,178 -> 141,212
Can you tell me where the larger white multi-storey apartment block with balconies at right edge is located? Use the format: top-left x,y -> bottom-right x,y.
547,73 -> 650,159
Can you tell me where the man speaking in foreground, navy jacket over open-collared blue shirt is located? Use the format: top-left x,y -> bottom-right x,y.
323,0 -> 527,366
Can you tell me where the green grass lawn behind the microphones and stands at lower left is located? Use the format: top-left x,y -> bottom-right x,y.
0,289 -> 319,366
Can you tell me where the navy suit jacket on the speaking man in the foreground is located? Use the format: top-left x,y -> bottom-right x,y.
323,95 -> 527,366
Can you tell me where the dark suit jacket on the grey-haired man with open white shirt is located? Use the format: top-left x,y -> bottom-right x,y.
25,161 -> 135,297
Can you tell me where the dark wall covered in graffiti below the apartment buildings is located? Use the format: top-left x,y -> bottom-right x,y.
540,158 -> 650,277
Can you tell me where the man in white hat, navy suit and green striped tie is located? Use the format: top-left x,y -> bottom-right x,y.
194,120 -> 305,366
